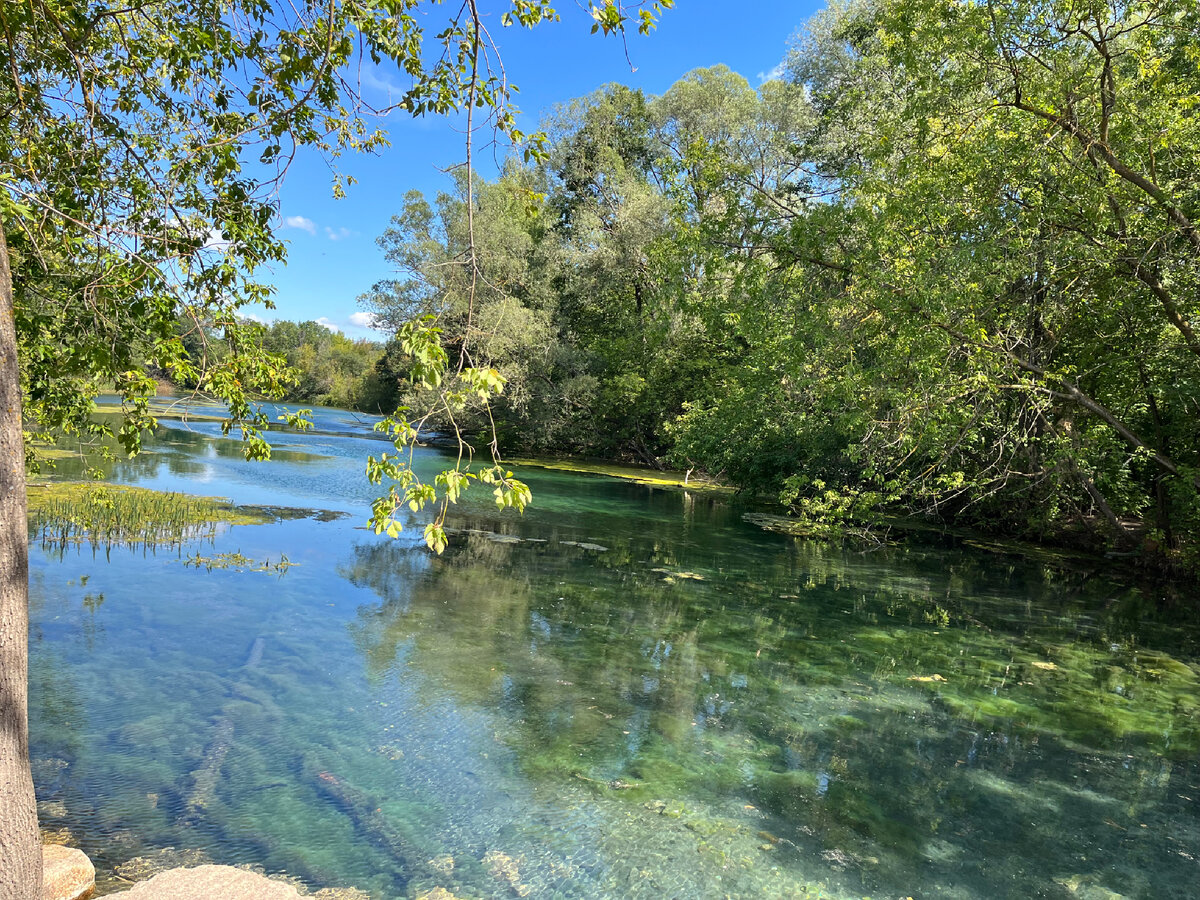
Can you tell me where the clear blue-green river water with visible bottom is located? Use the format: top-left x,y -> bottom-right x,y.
30,410 -> 1200,900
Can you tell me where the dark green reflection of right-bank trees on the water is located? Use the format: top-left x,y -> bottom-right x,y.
342,532 -> 1200,898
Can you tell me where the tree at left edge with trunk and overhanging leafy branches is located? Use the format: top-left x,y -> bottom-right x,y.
0,0 -> 671,900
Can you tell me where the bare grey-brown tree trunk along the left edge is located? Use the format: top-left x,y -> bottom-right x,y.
0,222 -> 42,900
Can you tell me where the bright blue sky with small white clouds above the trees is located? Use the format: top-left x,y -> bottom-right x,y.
260,0 -> 823,340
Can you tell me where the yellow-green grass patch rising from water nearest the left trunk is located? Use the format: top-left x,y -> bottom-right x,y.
29,482 -> 272,548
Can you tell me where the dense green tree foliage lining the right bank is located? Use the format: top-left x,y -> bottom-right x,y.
365,0 -> 1200,571
